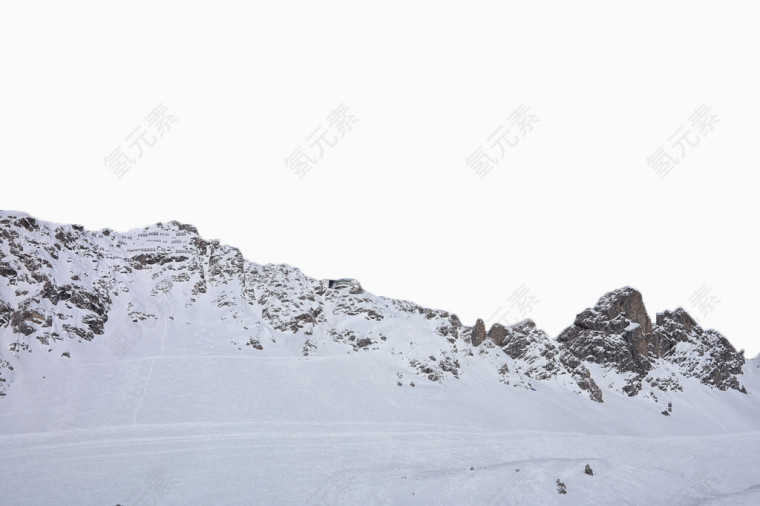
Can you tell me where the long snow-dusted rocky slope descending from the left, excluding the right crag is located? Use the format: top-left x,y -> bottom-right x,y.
0,213 -> 600,404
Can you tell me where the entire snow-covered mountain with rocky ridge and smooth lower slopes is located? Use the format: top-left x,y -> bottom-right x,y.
0,211 -> 760,504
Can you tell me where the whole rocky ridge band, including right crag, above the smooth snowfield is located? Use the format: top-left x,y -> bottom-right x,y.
0,211 -> 747,403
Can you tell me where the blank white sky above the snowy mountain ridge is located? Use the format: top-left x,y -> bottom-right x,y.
0,1 -> 760,356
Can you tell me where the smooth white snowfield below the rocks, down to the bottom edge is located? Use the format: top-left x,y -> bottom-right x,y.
0,313 -> 760,505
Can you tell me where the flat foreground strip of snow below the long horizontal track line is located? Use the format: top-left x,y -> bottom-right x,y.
0,422 -> 760,505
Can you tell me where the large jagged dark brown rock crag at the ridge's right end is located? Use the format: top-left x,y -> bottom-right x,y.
557,287 -> 744,395
